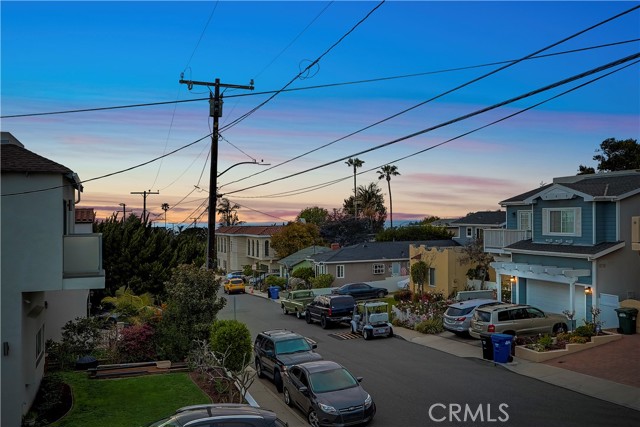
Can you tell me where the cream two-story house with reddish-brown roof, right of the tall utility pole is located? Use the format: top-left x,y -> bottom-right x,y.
216,225 -> 284,273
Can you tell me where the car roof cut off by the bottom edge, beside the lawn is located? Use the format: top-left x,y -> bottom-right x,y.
147,403 -> 287,427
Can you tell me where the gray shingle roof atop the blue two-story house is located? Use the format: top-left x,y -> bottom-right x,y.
500,170 -> 640,205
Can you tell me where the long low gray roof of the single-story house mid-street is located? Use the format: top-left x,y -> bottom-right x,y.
310,239 -> 460,263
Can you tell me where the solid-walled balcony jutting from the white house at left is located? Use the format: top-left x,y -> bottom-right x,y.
62,233 -> 105,289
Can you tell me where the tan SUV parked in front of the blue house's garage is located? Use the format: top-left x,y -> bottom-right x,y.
469,304 -> 567,338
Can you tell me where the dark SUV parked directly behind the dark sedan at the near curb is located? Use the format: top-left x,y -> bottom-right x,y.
253,329 -> 322,392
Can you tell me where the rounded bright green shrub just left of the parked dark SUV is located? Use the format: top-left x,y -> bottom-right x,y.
209,320 -> 252,372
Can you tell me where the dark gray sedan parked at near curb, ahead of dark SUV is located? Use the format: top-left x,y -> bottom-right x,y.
283,360 -> 376,427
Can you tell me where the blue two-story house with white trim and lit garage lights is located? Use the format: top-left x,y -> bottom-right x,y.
484,170 -> 640,328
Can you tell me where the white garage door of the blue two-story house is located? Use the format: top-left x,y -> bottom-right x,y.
527,279 -> 587,325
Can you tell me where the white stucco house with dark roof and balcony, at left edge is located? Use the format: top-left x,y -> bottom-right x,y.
0,132 -> 105,426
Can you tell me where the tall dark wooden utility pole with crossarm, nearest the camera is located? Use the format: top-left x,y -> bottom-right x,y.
180,78 -> 253,270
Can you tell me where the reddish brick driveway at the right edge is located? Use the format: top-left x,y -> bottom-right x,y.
544,334 -> 640,388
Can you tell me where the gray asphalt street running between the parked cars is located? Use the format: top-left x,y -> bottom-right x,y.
219,295 -> 640,427
